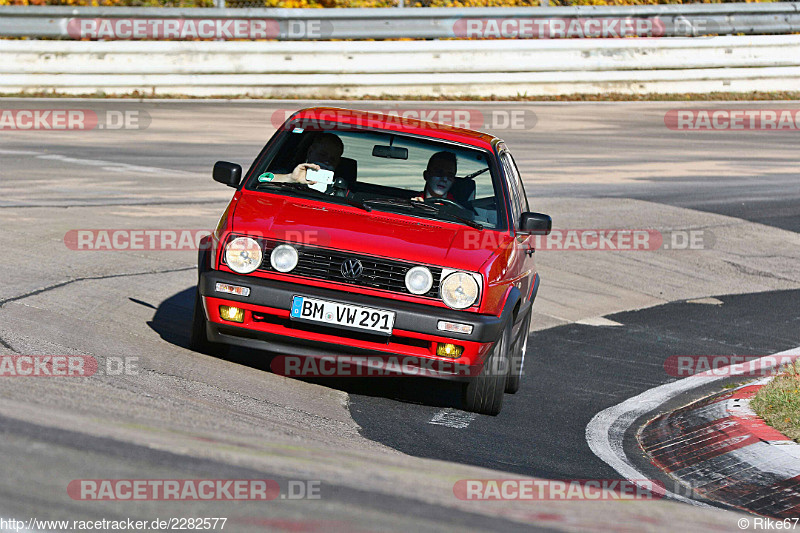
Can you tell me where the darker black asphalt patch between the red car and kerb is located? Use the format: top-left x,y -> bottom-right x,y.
350,291 -> 800,482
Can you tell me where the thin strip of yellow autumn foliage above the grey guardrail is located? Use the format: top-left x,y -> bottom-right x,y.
0,0 -> 770,8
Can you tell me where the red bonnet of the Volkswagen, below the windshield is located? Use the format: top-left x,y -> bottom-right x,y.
232,191 -> 510,272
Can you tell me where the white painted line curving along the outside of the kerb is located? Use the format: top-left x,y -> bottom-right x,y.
586,347 -> 800,506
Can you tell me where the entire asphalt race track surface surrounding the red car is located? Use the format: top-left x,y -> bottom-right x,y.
0,100 -> 800,531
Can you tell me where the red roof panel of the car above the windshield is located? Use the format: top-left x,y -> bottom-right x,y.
286,107 -> 502,149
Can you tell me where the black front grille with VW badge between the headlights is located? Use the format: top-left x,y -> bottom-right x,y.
259,240 -> 442,298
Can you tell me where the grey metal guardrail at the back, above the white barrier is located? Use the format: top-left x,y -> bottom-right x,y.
0,2 -> 800,40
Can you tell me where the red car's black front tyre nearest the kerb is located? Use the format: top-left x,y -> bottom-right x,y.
462,322 -> 511,416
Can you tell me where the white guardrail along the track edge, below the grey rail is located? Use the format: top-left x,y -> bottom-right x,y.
0,35 -> 800,98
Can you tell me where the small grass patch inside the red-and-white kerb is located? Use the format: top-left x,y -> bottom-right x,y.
750,360 -> 800,442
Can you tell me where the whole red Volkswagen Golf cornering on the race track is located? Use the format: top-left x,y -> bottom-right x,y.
192,108 -> 552,415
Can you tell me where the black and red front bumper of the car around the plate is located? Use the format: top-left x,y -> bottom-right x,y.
199,270 -> 502,379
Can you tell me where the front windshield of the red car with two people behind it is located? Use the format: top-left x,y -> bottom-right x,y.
246,127 -> 504,229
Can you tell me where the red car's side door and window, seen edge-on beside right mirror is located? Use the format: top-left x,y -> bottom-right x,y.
500,146 -> 536,299
